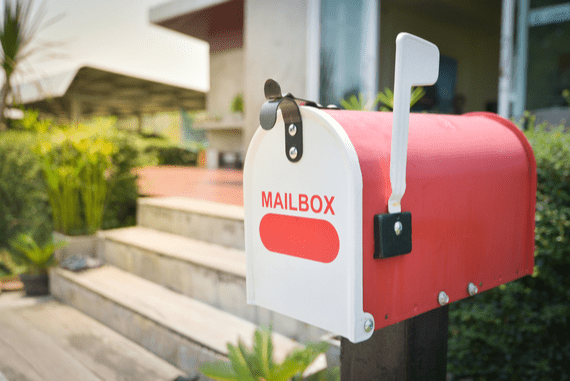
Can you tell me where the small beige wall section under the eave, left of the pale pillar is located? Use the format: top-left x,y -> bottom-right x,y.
206,49 -> 245,119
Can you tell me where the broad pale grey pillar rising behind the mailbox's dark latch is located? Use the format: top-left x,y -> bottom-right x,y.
242,0 -> 307,153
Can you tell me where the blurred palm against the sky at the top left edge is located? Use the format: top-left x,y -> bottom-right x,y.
0,0 -> 45,130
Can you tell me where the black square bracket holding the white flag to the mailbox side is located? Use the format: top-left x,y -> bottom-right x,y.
374,212 -> 412,259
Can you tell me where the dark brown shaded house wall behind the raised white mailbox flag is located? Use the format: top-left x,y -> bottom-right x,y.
379,6 -> 500,111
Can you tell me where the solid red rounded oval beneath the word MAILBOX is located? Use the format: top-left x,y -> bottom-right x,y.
259,213 -> 340,263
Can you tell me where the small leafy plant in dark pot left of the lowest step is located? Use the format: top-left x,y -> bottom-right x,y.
10,234 -> 66,296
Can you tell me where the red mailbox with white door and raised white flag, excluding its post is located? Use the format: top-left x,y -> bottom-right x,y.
244,33 -> 536,343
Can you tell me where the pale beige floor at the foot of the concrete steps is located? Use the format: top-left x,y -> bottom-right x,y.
0,293 -> 184,381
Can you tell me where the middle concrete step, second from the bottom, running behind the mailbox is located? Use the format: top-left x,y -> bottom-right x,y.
99,227 -> 327,342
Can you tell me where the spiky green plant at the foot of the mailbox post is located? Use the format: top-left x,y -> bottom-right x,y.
201,329 -> 340,381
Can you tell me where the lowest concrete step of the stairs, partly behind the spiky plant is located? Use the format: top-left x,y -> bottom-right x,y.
50,266 -> 326,377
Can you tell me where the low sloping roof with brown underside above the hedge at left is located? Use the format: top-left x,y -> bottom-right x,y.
15,66 -> 206,118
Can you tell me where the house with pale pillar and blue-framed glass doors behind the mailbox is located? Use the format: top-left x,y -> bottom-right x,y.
149,0 -> 570,166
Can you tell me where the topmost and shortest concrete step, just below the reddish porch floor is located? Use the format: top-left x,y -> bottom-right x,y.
137,197 -> 245,250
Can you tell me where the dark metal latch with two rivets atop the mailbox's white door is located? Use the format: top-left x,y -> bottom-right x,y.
259,79 -> 337,163
